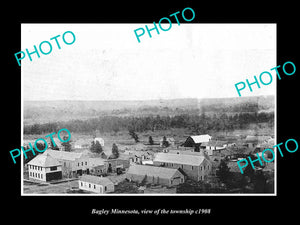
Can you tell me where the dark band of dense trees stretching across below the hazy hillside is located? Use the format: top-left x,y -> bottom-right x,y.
24,112 -> 274,134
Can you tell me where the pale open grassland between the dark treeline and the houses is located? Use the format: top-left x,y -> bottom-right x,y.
24,124 -> 275,155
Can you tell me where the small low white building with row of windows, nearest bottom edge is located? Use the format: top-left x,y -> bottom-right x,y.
78,175 -> 115,194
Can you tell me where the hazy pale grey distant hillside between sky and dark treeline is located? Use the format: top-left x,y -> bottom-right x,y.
24,96 -> 274,124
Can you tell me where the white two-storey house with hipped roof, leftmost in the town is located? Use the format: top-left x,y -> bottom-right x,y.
27,153 -> 62,182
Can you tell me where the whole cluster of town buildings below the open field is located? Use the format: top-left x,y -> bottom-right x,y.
27,134 -> 274,194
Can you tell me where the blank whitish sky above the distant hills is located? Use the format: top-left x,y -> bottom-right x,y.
21,23 -> 277,100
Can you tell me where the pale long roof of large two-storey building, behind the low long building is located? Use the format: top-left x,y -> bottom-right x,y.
153,153 -> 205,166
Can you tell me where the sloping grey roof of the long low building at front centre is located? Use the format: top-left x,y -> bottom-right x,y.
127,165 -> 180,179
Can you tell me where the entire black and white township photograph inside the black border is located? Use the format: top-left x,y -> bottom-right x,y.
21,24 -> 276,195
